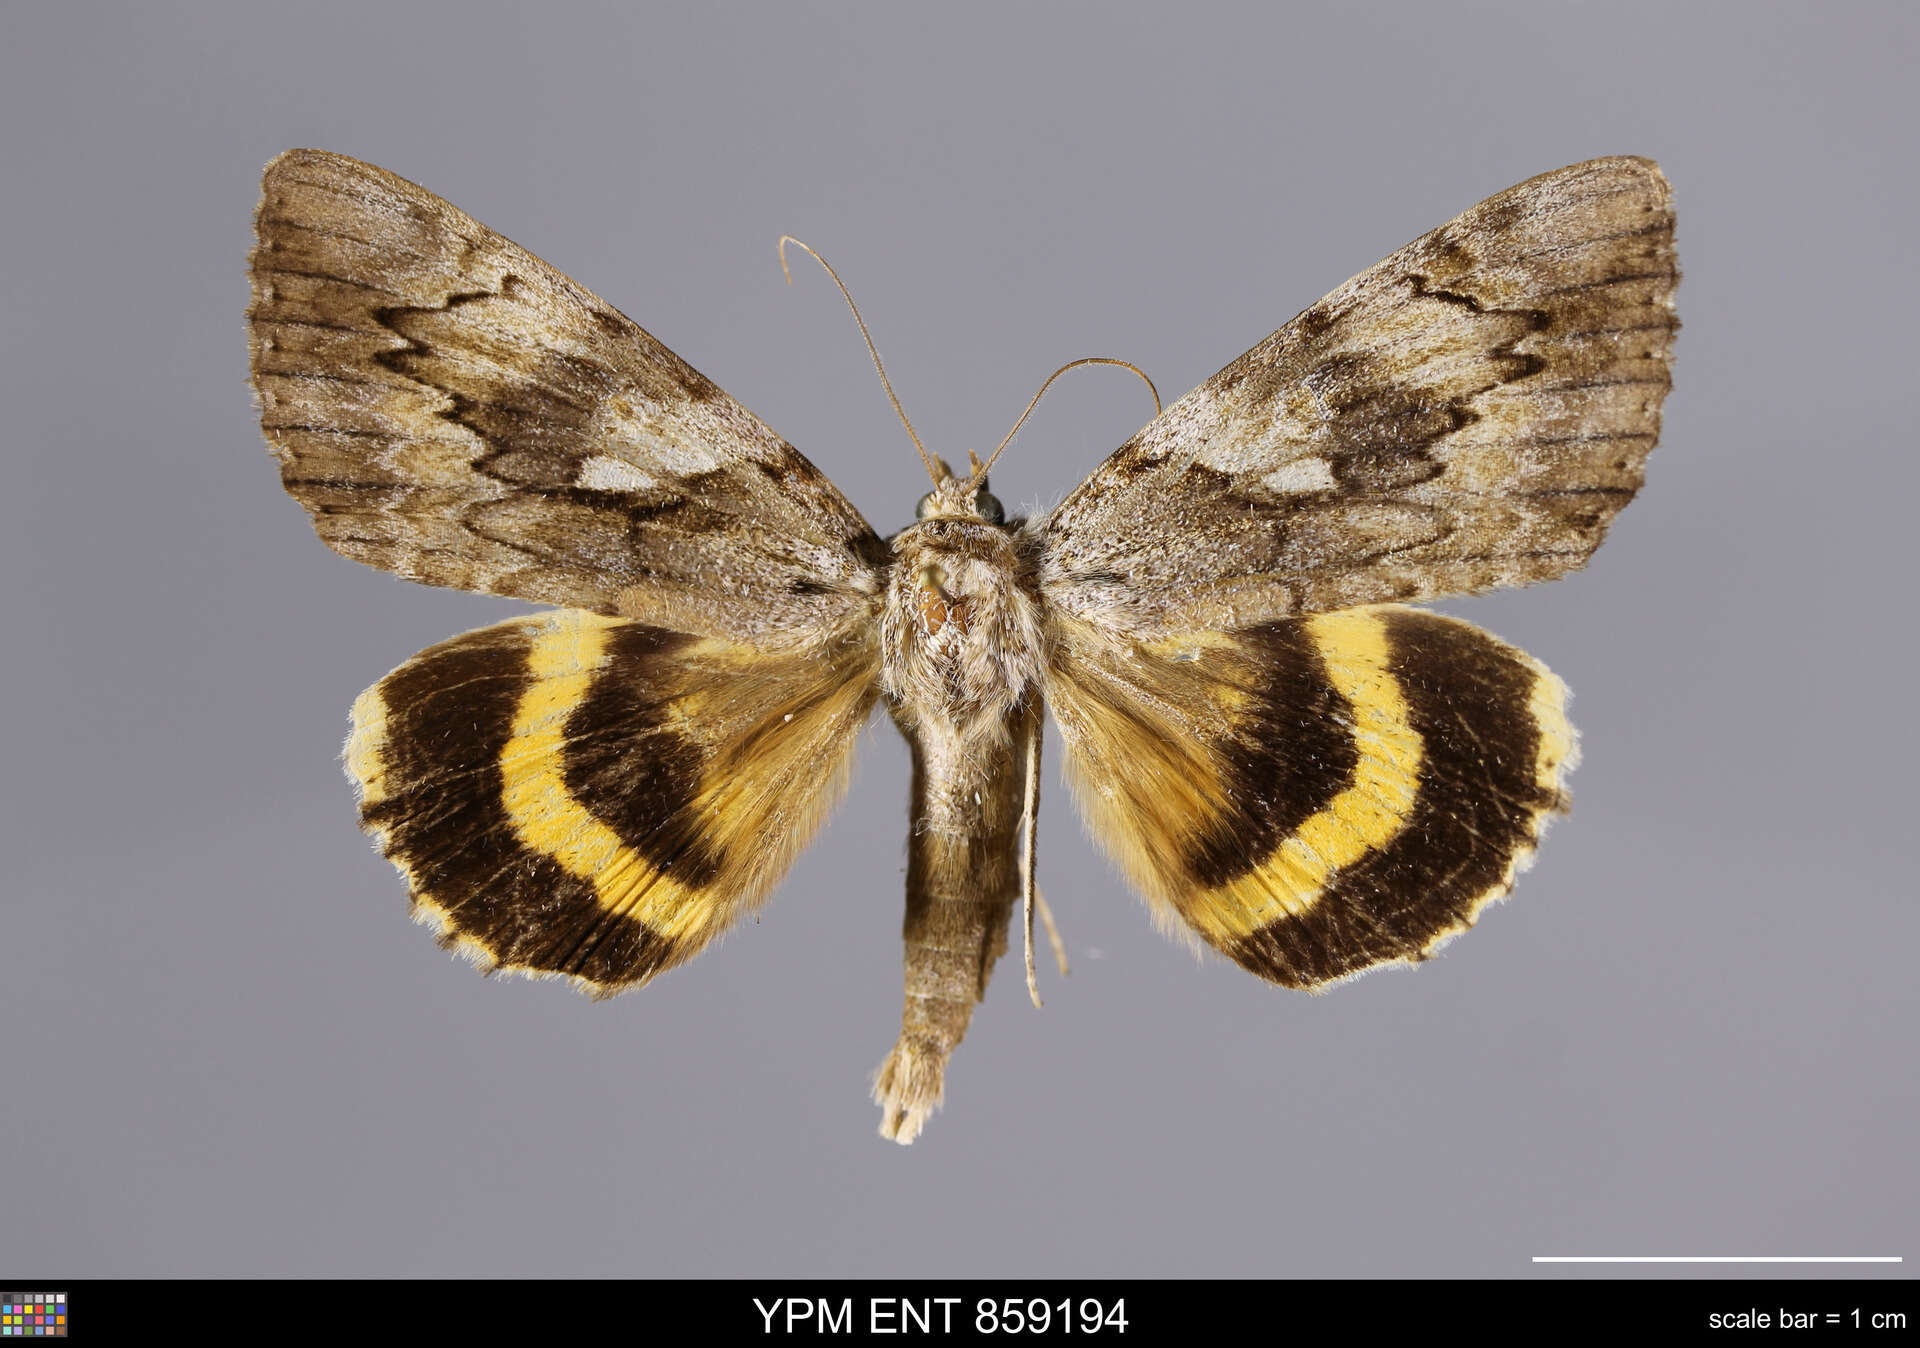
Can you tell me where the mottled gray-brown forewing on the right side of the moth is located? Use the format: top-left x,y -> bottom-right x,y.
1043,157 -> 1678,638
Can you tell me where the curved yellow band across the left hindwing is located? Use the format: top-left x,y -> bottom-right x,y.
499,611 -> 712,939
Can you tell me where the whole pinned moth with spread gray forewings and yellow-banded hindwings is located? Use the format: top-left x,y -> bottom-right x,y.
248,150 -> 1678,1143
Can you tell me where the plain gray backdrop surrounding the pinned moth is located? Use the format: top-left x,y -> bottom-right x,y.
0,0 -> 1920,1277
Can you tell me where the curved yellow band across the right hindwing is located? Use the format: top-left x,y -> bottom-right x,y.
1185,611 -> 1425,941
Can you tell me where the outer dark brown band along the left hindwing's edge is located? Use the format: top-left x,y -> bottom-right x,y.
348,620 -> 676,993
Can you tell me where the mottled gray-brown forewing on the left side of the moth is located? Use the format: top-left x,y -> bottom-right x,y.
248,150 -> 879,639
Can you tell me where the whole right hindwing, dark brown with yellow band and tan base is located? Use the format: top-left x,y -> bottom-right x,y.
1048,605 -> 1574,989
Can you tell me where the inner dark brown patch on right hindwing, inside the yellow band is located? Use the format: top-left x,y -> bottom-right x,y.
1185,622 -> 1359,889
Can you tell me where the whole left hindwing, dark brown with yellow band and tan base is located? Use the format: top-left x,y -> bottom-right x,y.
346,611 -> 877,995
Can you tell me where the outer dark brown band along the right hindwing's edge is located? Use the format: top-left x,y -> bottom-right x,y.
1221,609 -> 1571,987
